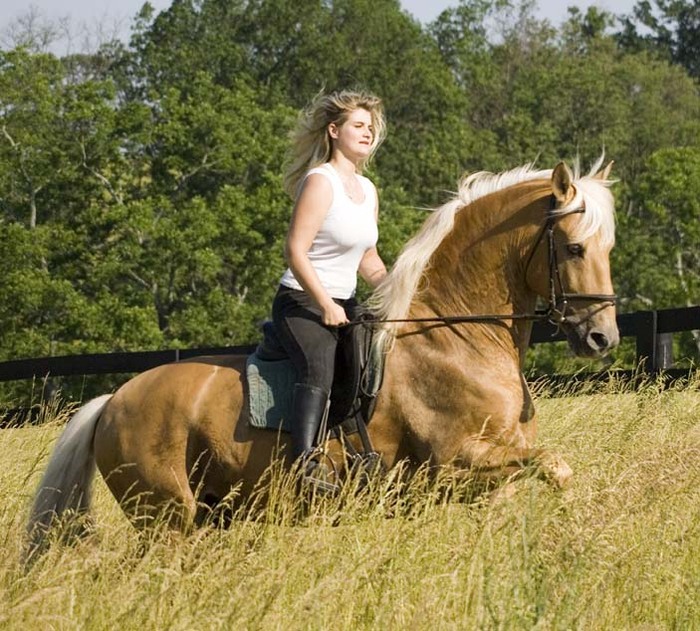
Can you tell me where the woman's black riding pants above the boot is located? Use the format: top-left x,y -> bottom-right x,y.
272,286 -> 359,393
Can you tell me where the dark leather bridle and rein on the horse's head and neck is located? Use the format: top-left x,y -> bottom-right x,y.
350,195 -> 617,328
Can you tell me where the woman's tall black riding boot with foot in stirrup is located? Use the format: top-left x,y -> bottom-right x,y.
290,383 -> 339,494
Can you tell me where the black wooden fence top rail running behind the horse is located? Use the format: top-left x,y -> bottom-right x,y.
0,307 -> 700,381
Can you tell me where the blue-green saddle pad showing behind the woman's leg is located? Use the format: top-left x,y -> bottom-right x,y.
246,353 -> 296,432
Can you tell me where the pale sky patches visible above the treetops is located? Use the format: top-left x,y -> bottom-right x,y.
0,0 -> 637,47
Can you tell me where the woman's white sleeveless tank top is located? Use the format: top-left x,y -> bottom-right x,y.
280,162 -> 378,299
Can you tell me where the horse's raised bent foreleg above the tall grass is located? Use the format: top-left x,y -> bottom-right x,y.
457,439 -> 573,488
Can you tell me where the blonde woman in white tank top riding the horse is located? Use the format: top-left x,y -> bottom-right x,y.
272,91 -> 386,491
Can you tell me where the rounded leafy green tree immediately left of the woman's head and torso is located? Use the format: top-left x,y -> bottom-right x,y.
65,74 -> 290,345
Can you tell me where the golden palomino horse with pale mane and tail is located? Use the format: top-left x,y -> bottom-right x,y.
29,160 -> 618,545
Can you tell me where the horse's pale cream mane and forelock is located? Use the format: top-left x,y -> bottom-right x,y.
369,156 -> 615,333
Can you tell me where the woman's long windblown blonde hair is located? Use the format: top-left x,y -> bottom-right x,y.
284,90 -> 386,197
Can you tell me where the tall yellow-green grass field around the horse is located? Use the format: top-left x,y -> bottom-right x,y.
0,379 -> 700,631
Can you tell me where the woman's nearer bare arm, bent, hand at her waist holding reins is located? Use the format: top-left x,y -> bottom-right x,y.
284,173 -> 348,326
